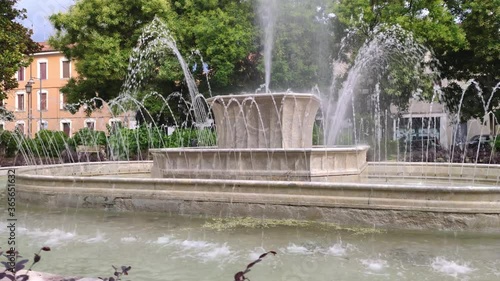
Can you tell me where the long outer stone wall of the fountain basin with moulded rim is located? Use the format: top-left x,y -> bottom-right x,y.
10,161 -> 500,231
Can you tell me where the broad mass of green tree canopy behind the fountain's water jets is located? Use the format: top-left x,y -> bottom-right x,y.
49,0 -> 500,130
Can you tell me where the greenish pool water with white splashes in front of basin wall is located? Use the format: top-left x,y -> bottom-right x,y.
0,177 -> 500,281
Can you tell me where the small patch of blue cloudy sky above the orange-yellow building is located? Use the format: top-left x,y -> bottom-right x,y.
17,0 -> 74,42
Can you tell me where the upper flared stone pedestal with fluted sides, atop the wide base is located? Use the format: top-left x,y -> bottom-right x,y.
207,93 -> 320,148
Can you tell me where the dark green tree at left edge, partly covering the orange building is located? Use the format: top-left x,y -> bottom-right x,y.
0,0 -> 41,103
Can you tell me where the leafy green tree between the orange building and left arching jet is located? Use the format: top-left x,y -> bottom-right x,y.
49,0 -> 174,103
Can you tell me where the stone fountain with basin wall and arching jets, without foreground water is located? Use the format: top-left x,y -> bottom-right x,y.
9,11 -> 500,230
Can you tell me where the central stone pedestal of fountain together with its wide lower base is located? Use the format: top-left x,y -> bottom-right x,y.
150,93 -> 368,181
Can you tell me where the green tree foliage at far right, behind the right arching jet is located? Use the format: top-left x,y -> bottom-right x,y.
333,0 -> 500,137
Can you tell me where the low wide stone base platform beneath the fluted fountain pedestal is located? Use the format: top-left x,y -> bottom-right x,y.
150,146 -> 369,182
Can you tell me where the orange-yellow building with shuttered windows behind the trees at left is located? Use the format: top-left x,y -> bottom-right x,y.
0,43 -> 128,137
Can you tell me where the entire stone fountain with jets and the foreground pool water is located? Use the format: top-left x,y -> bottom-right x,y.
0,1 -> 500,281
